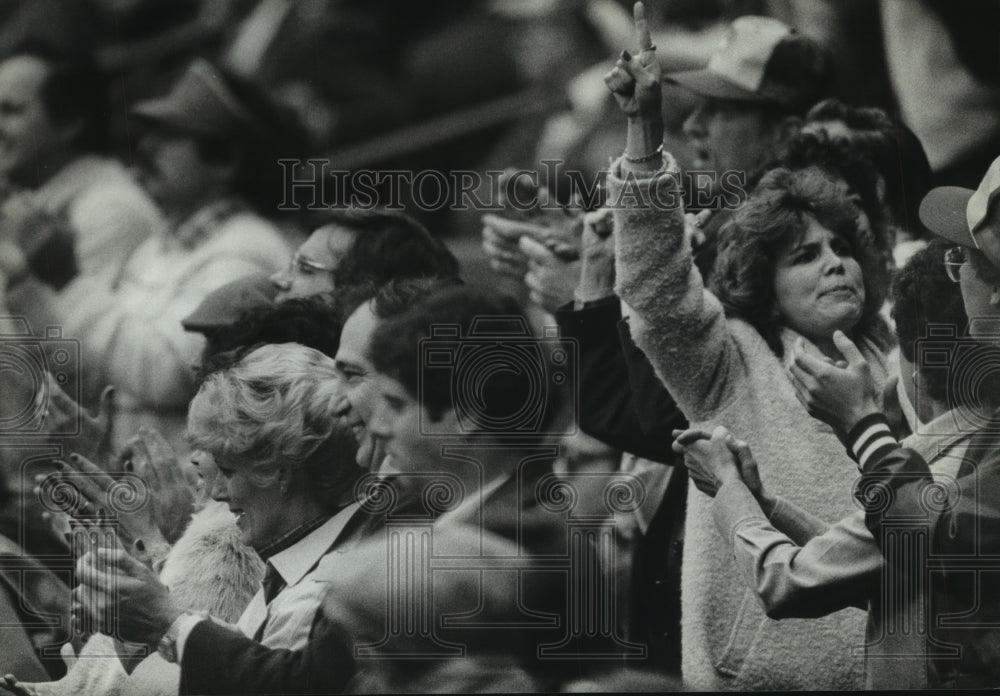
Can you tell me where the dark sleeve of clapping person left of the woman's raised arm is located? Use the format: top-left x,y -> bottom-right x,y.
555,296 -> 677,463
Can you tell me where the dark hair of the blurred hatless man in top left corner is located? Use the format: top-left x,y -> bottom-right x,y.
8,40 -> 111,154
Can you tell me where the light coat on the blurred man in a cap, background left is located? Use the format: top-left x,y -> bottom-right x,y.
16,201 -> 291,452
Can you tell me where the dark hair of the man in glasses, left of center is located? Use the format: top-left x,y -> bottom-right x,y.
312,209 -> 458,287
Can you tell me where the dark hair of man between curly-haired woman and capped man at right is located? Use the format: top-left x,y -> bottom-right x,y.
892,240 -> 969,401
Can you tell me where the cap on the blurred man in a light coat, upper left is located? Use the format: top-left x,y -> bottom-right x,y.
132,58 -> 263,135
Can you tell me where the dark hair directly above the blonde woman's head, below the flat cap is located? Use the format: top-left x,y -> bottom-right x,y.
197,295 -> 341,383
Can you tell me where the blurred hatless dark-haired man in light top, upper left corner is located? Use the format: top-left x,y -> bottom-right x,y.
0,43 -> 161,290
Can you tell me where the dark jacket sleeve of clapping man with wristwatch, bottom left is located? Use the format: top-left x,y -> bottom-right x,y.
180,612 -> 355,695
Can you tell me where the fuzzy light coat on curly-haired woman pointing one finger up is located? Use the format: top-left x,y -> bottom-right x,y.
608,155 -> 887,690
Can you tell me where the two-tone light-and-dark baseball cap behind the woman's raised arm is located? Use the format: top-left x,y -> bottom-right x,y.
666,15 -> 832,110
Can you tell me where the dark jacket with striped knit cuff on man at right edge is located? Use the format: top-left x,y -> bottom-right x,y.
848,414 -> 1000,688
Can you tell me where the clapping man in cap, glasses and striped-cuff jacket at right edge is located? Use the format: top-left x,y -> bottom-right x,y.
788,158 -> 1000,689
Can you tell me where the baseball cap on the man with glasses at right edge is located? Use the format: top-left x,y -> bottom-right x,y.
920,157 -> 1000,250
